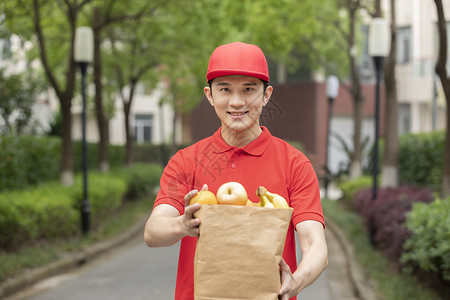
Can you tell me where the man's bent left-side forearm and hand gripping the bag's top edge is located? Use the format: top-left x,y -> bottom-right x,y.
144,187 -> 202,247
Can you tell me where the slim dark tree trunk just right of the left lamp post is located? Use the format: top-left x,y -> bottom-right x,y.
92,7 -> 109,172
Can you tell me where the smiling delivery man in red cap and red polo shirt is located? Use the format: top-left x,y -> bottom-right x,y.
144,43 -> 328,300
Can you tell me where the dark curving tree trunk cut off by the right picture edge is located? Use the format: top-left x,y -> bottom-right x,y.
434,0 -> 450,197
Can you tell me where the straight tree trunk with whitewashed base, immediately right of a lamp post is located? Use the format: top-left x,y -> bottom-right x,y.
381,0 -> 398,187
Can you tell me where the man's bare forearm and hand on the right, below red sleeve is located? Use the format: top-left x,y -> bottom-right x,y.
279,221 -> 328,300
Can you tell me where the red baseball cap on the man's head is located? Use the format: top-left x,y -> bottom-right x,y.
206,42 -> 269,81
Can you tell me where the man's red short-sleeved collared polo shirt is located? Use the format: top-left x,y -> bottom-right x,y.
155,127 -> 325,300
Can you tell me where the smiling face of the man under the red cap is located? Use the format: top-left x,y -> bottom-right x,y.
205,75 -> 272,132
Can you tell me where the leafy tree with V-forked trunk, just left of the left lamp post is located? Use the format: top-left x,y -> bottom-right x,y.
2,0 -> 91,185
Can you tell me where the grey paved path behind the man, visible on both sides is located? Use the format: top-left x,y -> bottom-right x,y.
8,225 -> 357,300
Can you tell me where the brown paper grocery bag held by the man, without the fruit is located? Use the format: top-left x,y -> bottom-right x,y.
194,205 -> 293,300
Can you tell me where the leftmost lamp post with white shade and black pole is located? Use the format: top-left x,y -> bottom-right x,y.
74,26 -> 94,234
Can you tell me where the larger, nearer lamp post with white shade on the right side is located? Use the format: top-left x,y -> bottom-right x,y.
369,18 -> 390,244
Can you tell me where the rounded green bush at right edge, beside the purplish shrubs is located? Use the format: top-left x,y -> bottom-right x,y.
401,198 -> 450,283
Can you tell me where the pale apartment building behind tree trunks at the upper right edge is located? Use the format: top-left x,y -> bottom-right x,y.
383,0 -> 450,134
